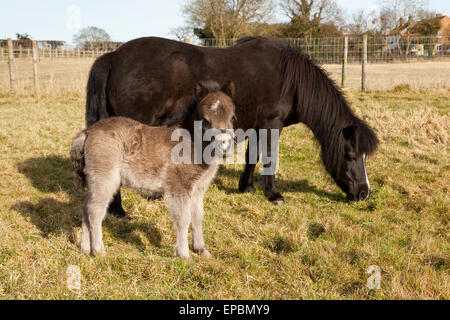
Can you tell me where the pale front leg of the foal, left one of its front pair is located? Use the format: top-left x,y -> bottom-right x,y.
165,194 -> 191,258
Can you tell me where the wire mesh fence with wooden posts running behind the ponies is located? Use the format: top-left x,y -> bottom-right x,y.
0,36 -> 450,94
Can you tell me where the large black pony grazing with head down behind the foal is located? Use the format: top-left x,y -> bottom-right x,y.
86,37 -> 378,216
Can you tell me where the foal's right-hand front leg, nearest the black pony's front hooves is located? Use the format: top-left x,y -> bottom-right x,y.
191,192 -> 211,257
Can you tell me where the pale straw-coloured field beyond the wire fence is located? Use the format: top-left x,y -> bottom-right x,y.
0,58 -> 450,95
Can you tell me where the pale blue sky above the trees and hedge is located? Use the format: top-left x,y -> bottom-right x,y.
0,0 -> 450,42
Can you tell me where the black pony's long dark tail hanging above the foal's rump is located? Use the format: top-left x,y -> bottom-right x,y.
86,52 -> 114,128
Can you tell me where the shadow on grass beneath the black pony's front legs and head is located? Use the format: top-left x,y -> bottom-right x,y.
214,166 -> 347,202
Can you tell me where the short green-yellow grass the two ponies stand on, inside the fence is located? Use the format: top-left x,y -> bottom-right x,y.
0,87 -> 450,299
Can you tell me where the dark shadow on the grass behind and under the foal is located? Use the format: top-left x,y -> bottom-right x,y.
11,156 -> 161,249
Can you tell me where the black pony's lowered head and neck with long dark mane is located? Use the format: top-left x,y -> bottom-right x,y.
280,47 -> 378,200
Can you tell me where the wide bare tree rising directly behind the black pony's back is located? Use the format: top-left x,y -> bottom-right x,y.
183,0 -> 274,39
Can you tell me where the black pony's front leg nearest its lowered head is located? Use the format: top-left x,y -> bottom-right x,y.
259,119 -> 284,205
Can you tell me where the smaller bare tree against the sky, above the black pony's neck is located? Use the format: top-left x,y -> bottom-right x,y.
281,0 -> 344,36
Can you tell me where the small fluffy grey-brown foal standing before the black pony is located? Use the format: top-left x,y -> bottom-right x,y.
70,81 -> 234,258
